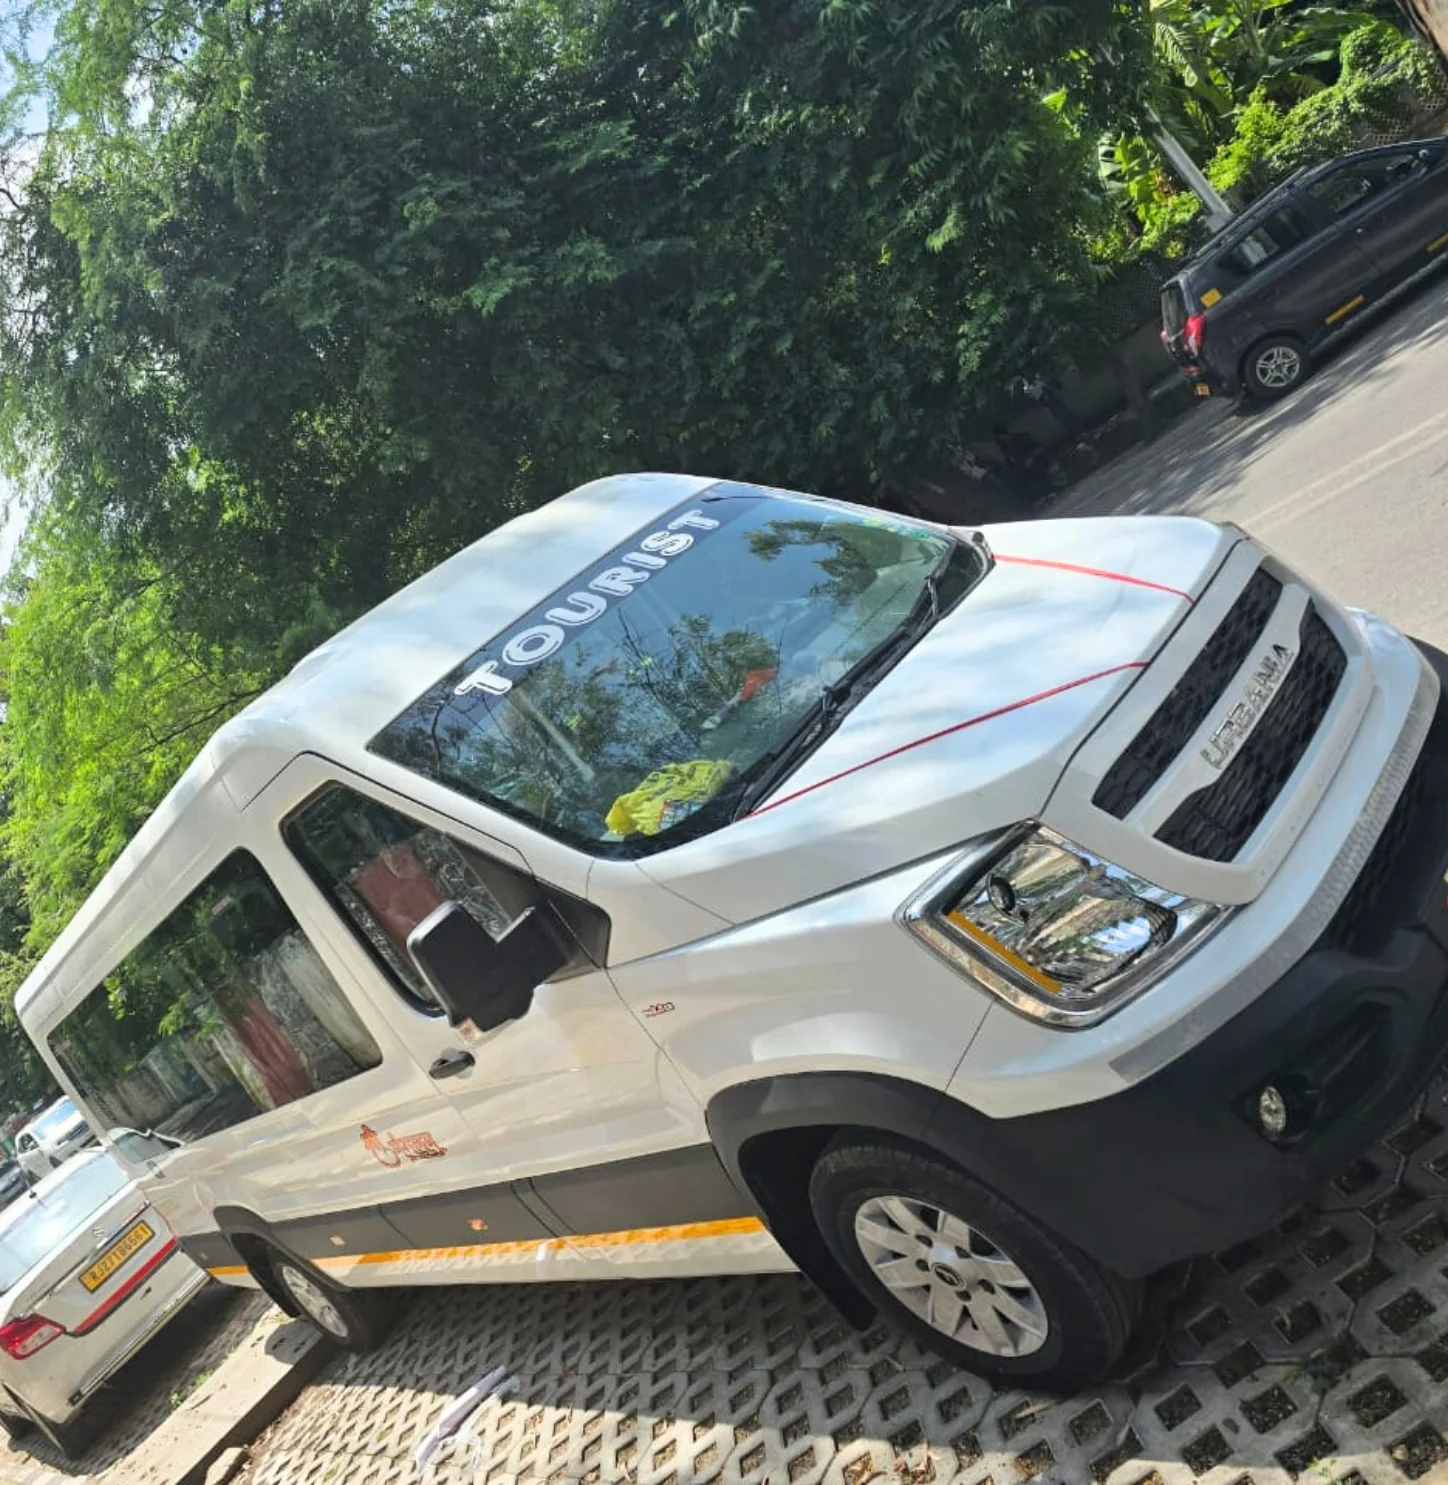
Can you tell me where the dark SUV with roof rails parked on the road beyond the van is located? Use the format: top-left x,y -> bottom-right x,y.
1161,140 -> 1448,398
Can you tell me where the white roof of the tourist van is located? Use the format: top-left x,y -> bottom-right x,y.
15,474 -> 719,1013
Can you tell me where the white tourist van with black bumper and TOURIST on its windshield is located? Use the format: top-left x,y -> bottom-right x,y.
11,475 -> 1448,1386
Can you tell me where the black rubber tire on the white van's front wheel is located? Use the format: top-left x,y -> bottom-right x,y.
809,1136 -> 1141,1388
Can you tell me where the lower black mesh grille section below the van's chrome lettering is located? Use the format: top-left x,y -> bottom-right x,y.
1157,607 -> 1347,861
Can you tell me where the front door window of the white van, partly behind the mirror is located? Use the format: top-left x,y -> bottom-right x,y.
284,784 -> 567,1011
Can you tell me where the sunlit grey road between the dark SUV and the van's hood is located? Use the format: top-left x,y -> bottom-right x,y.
1056,267 -> 1448,647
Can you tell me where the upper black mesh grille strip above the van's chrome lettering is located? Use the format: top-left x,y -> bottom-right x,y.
1092,567 -> 1282,820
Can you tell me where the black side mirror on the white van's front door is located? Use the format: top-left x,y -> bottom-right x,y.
407,901 -> 573,1031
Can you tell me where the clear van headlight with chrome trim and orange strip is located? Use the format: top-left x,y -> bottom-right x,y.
901,826 -> 1224,1026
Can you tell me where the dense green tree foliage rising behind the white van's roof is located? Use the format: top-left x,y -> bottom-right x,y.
0,0 -> 1147,1104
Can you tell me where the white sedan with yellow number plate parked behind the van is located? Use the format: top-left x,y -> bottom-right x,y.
0,1135 -> 208,1457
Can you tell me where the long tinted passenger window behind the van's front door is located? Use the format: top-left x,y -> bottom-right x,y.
50,851 -> 382,1140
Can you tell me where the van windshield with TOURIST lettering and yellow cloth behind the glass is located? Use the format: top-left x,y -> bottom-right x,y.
371,486 -> 956,855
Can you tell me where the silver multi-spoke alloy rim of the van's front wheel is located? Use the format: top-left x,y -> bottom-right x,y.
855,1197 -> 1050,1356
